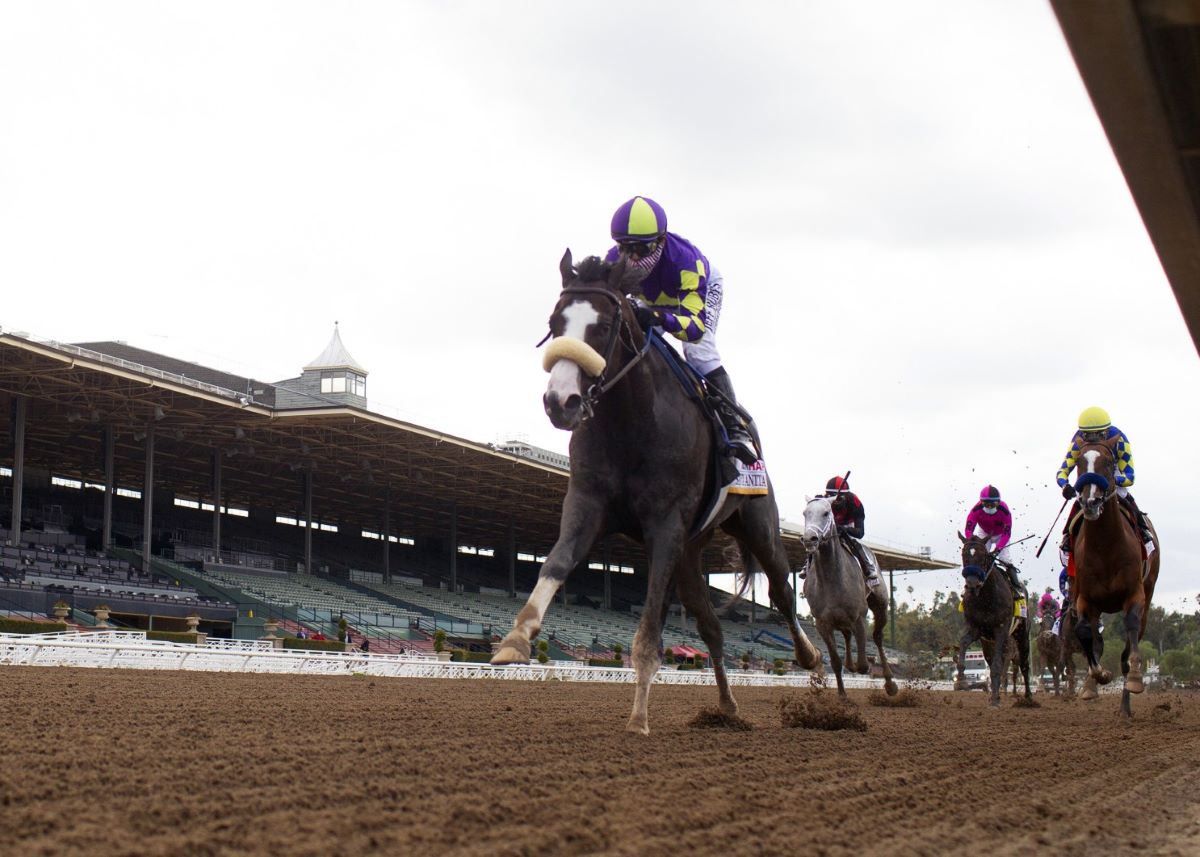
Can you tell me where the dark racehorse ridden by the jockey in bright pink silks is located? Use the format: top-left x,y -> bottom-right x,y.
954,533 -> 1033,707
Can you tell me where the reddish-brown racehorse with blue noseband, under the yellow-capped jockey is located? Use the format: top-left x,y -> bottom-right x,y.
1073,439 -> 1162,717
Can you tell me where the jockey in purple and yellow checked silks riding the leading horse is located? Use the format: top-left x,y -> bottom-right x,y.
605,197 -> 758,465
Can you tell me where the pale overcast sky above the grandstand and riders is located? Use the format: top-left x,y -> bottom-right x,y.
0,0 -> 1200,610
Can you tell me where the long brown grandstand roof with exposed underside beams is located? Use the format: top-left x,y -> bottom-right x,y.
0,332 -> 952,571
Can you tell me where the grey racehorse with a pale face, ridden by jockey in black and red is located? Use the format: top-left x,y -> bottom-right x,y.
804,497 -> 898,696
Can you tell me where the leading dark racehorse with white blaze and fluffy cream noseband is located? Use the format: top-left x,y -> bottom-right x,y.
492,251 -> 820,735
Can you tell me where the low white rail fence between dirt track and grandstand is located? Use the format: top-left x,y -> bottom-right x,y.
0,630 -> 952,690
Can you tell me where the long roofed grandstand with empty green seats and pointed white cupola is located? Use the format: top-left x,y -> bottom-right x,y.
0,329 -> 949,659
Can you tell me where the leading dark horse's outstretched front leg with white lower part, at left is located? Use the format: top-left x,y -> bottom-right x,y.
492,491 -> 604,664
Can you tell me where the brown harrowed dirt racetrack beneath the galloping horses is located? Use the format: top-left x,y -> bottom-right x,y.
0,667 -> 1200,857
